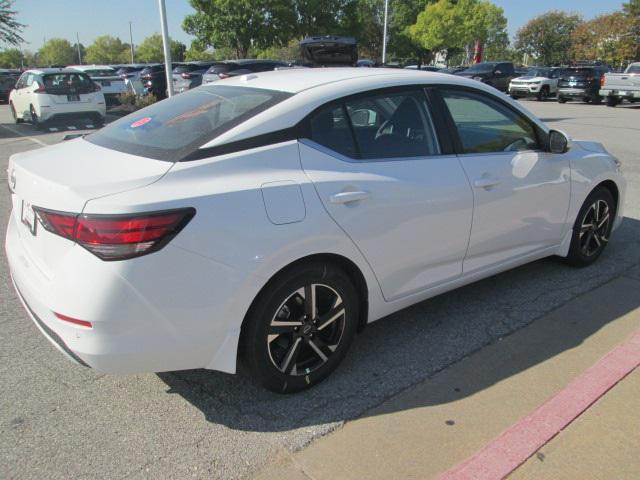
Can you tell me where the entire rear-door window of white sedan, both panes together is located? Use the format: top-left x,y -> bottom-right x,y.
311,90 -> 440,159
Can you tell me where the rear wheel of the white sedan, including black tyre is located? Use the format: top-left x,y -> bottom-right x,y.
241,263 -> 359,393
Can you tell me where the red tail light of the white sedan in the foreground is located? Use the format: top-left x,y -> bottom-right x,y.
34,208 -> 196,260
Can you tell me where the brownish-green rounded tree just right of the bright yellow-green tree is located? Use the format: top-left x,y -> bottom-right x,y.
515,11 -> 582,65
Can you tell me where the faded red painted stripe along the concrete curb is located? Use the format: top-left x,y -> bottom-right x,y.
438,330 -> 640,480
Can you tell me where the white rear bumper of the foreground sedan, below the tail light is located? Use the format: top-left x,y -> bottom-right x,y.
5,212 -> 248,373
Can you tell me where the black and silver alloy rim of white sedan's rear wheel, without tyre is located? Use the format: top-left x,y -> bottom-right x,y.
267,283 -> 345,376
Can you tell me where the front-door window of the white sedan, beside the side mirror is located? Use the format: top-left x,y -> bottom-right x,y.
442,90 -> 539,153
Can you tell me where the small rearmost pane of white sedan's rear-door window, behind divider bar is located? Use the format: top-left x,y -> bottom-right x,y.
309,105 -> 356,157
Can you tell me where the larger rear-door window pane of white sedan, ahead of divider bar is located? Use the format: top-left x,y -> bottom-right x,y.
345,91 -> 438,158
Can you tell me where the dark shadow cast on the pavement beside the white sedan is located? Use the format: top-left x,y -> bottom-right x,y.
159,218 -> 640,436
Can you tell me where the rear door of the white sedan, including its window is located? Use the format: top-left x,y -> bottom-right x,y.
300,89 -> 473,300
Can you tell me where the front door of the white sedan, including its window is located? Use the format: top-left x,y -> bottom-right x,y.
440,87 -> 570,273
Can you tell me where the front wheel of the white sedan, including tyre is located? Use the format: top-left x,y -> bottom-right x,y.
567,188 -> 616,267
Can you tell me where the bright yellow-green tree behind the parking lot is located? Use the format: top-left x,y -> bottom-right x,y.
408,0 -> 509,62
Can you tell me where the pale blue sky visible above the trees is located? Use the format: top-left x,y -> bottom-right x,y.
13,0 -> 623,51
